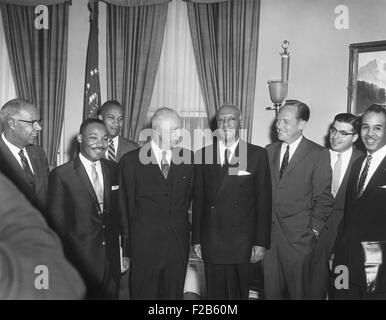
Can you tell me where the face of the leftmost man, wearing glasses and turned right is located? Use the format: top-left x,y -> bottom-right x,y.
6,104 -> 42,149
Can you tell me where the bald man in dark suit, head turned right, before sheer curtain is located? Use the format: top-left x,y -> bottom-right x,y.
119,108 -> 194,299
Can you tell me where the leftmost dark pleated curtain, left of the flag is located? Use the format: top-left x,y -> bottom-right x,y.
0,1 -> 68,167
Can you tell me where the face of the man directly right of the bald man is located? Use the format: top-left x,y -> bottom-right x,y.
216,106 -> 241,146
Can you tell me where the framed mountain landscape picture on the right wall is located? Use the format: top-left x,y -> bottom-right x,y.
347,41 -> 386,115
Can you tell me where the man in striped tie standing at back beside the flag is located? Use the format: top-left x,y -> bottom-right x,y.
99,100 -> 139,162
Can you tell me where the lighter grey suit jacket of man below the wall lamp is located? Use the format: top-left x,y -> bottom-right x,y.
267,137 -> 334,249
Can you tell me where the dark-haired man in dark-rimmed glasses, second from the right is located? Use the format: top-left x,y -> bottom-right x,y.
307,113 -> 362,300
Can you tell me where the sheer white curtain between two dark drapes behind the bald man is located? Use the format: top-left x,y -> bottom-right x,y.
147,0 -> 209,150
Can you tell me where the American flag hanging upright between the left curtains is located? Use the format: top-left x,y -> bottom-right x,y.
83,0 -> 101,120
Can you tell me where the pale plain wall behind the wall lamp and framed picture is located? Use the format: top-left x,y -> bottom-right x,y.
252,0 -> 386,146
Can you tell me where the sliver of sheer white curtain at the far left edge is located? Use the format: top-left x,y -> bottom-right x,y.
0,10 -> 16,133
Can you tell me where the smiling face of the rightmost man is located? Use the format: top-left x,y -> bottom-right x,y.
361,111 -> 386,153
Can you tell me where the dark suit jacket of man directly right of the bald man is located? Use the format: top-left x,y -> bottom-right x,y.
192,141 -> 272,264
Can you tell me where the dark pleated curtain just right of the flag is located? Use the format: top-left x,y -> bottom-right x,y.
107,2 -> 168,141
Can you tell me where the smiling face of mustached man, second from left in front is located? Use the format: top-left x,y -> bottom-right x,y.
78,123 -> 109,162
